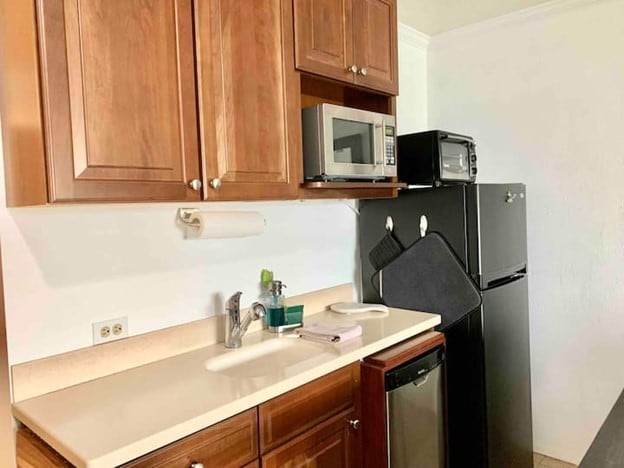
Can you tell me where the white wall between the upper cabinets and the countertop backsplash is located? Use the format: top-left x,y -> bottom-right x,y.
0,125 -> 356,364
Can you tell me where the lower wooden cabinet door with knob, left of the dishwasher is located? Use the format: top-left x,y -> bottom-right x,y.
262,410 -> 359,468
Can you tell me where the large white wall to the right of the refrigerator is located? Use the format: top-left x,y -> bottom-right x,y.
428,0 -> 624,463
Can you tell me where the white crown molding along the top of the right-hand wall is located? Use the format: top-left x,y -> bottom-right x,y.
429,0 -> 604,49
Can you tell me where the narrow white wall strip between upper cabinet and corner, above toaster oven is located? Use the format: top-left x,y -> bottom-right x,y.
396,23 -> 429,135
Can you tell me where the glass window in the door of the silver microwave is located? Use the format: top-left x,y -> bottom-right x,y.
332,119 -> 375,164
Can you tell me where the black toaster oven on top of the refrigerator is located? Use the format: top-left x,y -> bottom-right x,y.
397,130 -> 477,186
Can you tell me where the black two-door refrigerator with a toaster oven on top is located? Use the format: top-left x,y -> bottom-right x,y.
359,184 -> 533,468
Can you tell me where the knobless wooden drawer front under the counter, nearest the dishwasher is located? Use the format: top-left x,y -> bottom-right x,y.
259,362 -> 360,453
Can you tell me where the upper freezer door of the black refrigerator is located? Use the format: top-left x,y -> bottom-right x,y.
466,184 -> 527,289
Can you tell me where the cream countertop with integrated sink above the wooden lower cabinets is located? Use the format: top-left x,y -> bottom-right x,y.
13,309 -> 440,468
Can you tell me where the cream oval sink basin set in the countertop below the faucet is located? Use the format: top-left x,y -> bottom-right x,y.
205,337 -> 336,379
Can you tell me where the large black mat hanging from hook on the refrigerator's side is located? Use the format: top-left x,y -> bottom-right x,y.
371,232 -> 481,330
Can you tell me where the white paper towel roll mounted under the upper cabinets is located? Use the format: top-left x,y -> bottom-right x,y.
186,211 -> 266,239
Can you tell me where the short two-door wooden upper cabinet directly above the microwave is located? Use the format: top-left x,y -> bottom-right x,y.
294,0 -> 398,95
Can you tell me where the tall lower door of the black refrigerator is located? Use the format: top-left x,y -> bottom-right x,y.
482,276 -> 533,468
